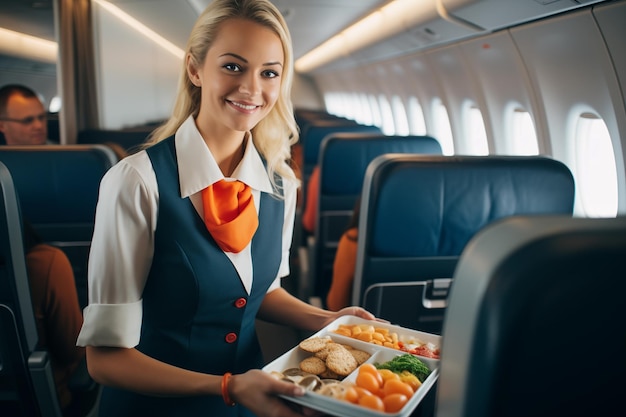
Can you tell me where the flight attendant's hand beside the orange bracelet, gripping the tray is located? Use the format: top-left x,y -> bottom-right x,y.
228,369 -> 310,417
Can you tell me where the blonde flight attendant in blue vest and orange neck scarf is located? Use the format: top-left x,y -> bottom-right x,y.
78,0 -> 374,417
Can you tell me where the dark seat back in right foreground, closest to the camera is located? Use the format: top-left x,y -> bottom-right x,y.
435,216 -> 626,417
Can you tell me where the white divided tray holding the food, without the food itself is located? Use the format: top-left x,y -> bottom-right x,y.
263,316 -> 440,417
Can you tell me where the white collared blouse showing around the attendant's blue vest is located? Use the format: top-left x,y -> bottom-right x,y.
77,116 -> 298,348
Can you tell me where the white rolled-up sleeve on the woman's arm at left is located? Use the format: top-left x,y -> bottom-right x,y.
77,152 -> 158,348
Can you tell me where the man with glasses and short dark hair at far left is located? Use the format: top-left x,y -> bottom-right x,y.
0,84 -> 48,145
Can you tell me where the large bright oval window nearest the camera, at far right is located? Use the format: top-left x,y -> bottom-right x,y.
575,113 -> 618,217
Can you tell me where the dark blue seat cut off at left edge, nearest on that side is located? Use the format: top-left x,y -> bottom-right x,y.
0,162 -> 99,417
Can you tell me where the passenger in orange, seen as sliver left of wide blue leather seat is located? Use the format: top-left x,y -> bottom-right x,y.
326,198 -> 361,311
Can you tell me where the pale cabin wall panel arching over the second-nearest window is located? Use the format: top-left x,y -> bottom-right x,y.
459,31 -> 545,155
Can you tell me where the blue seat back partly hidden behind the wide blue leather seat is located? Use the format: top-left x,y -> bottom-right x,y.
312,132 -> 441,299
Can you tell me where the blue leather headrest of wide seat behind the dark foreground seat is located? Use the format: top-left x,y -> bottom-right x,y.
361,155 -> 574,257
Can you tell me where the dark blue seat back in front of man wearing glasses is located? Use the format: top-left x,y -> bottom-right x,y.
0,145 -> 117,307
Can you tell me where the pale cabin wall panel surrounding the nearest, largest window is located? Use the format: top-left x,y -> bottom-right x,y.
511,9 -> 626,213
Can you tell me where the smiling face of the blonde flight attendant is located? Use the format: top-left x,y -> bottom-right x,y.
187,19 -> 284,140
